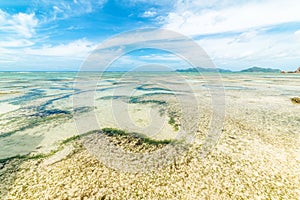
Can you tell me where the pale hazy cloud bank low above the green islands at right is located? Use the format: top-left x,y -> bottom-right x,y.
197,29 -> 300,69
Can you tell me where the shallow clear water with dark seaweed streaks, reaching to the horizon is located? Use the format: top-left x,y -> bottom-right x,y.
0,72 -> 300,159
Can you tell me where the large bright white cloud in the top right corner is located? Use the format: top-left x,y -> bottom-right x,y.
164,0 -> 300,35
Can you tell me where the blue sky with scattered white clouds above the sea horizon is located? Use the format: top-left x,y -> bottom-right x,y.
0,0 -> 300,71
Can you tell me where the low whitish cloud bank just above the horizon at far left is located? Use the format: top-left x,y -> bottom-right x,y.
0,39 -> 95,70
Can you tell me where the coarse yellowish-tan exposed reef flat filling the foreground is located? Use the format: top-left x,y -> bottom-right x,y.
4,122 -> 300,199
